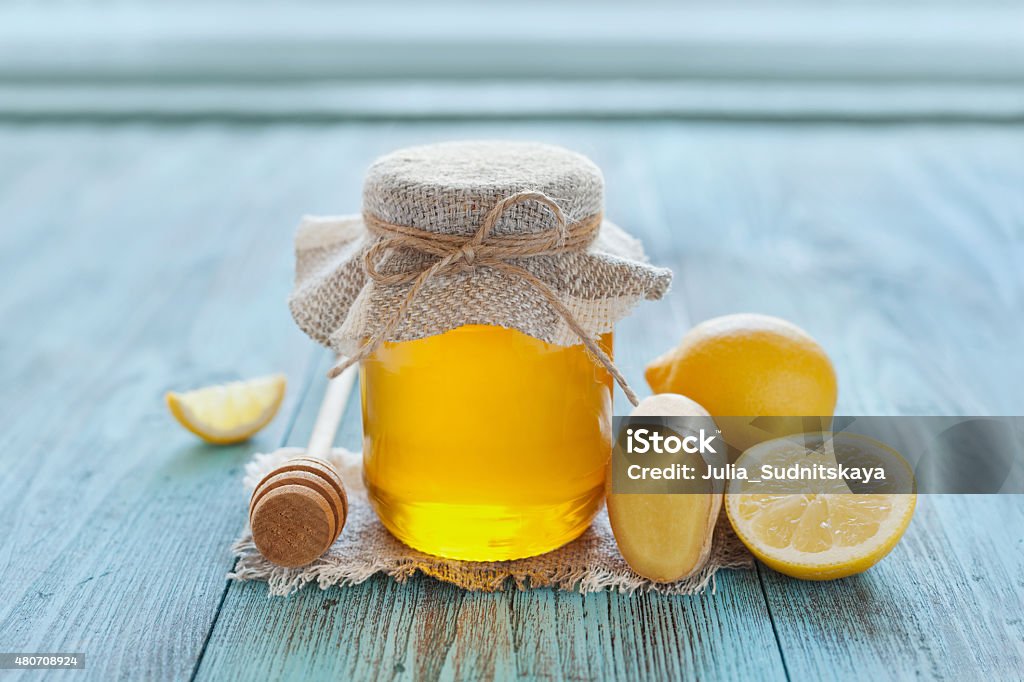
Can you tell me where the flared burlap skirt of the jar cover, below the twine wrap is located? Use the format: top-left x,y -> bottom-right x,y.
289,215 -> 672,356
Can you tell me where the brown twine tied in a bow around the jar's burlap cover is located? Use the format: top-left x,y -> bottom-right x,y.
328,191 -> 638,406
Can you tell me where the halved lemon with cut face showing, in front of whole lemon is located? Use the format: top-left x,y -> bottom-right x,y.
725,433 -> 916,581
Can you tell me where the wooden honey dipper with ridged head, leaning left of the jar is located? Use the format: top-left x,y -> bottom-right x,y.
249,367 -> 355,567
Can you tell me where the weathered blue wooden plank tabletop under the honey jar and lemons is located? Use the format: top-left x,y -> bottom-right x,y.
0,120 -> 1024,682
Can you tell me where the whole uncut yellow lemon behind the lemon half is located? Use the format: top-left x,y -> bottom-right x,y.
644,313 -> 837,451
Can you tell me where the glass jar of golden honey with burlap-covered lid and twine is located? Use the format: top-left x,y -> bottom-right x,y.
291,142 -> 671,561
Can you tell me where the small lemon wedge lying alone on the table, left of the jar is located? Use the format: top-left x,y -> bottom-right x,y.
167,374 -> 287,444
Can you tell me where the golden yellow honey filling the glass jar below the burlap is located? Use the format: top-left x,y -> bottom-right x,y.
359,325 -> 612,561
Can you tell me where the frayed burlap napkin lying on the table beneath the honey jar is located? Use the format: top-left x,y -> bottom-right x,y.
227,447 -> 753,596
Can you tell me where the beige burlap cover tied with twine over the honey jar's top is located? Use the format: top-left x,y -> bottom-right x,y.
291,142 -> 672,402
